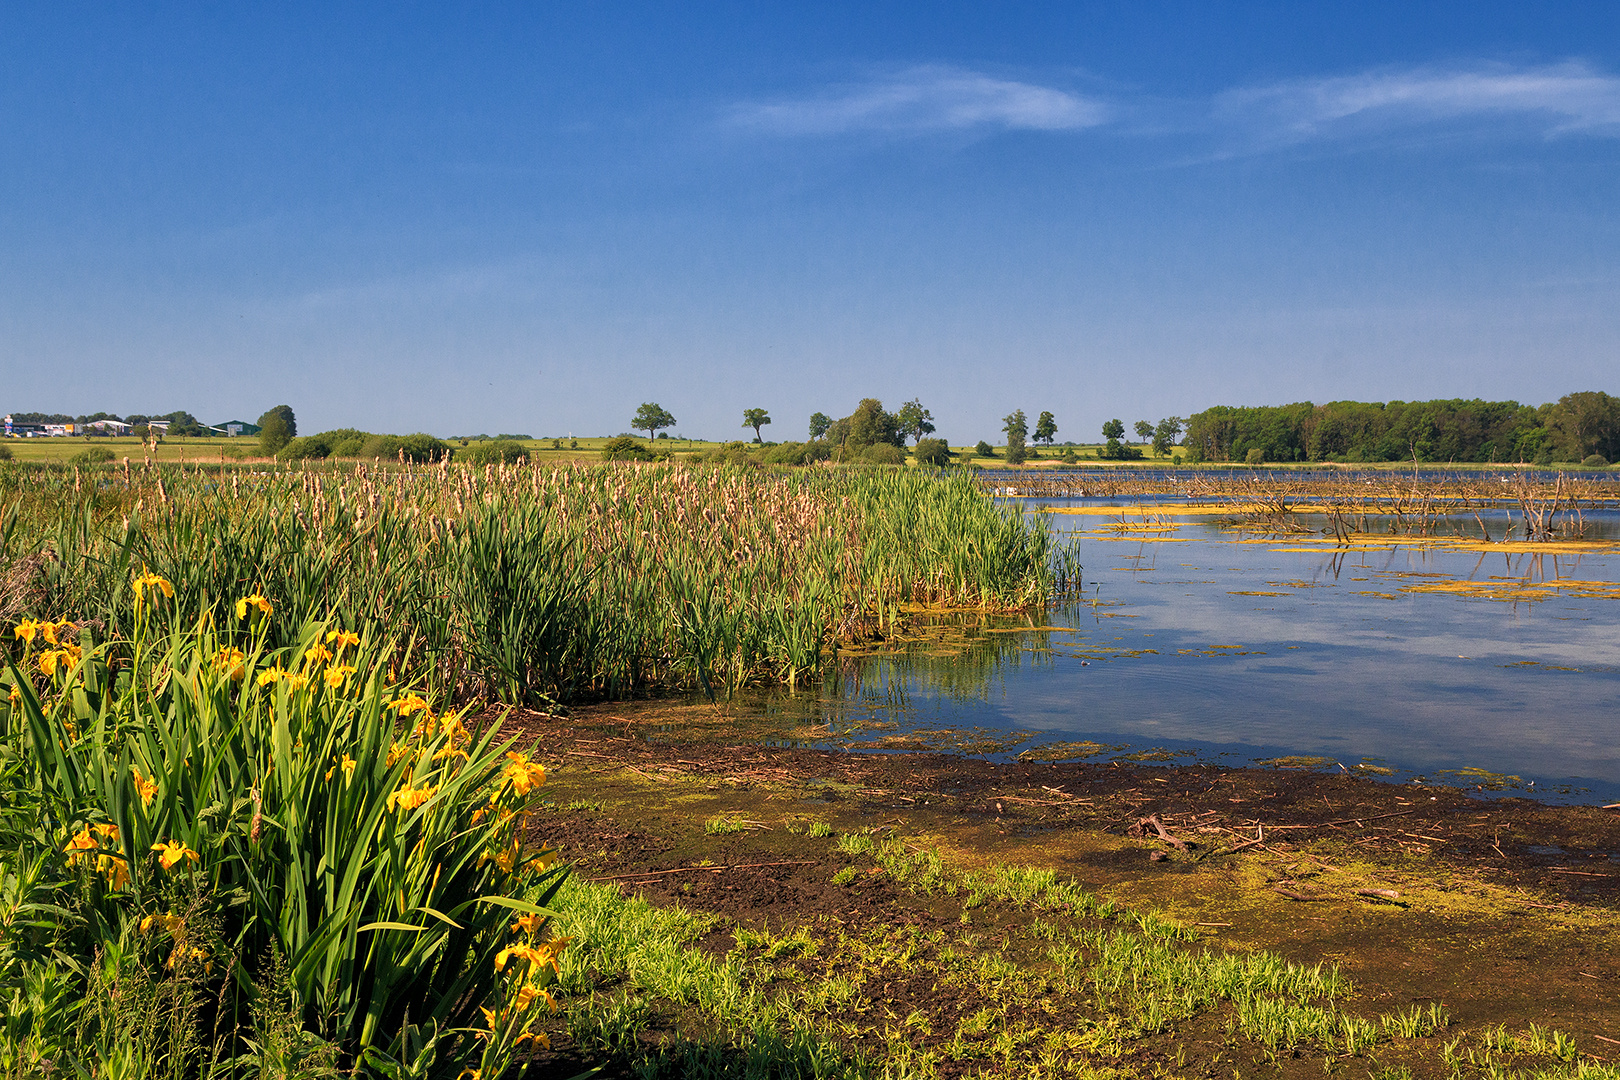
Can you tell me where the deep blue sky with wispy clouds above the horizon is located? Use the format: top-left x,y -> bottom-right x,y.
0,0 -> 1620,442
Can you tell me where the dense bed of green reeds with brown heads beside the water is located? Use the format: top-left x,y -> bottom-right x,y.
0,465 -> 1079,704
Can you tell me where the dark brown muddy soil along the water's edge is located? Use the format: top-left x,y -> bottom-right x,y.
505,703 -> 1620,1075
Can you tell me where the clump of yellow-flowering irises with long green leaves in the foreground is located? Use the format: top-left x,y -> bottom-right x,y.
0,599 -> 565,1077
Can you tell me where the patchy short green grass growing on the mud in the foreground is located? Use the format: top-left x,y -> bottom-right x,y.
537,822 -> 1620,1080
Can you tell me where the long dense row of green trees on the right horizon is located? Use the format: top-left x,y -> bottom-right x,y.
1186,390 -> 1620,465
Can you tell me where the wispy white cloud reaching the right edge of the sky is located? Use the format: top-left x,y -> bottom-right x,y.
1213,62 -> 1620,142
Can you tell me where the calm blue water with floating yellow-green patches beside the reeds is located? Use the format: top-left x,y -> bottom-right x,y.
754,513 -> 1620,801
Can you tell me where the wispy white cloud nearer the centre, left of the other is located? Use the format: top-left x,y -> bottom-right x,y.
727,66 -> 1110,136
